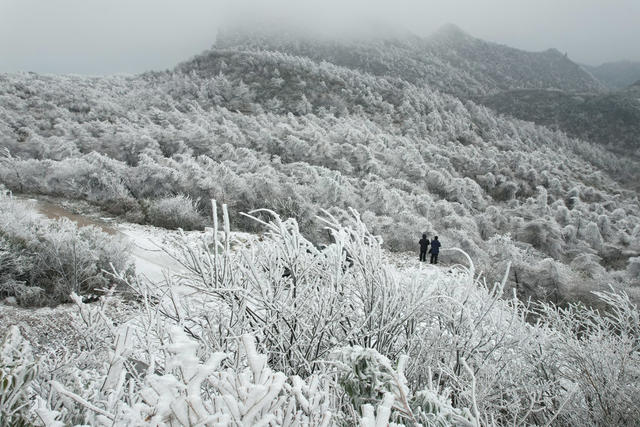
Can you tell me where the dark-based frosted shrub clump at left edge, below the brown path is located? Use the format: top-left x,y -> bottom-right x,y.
0,196 -> 131,305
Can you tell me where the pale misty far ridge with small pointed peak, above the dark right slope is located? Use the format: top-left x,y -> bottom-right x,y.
216,24 -> 605,99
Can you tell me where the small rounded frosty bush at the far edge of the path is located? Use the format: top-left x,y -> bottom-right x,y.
147,194 -> 204,230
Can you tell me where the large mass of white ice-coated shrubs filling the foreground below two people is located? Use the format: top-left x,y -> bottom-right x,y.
8,204 -> 640,426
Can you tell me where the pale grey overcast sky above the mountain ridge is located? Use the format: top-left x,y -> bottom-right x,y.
0,0 -> 640,74
